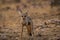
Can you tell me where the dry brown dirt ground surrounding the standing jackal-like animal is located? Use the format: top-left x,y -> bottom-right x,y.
0,0 -> 60,40
